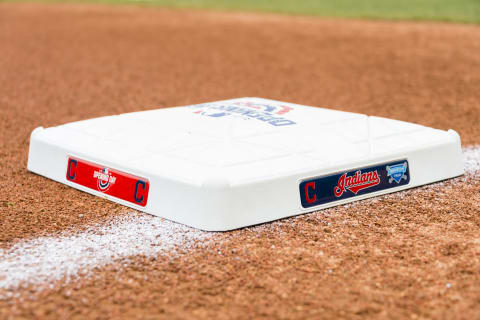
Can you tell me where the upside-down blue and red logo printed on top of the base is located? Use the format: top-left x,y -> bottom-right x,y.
192,101 -> 296,127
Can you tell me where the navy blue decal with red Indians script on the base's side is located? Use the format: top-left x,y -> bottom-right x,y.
299,160 -> 410,208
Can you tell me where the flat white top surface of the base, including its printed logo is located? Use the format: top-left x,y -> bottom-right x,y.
32,98 -> 454,185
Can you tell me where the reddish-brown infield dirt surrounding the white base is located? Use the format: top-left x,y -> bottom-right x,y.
0,3 -> 480,319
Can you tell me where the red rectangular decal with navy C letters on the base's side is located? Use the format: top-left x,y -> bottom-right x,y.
66,157 -> 150,207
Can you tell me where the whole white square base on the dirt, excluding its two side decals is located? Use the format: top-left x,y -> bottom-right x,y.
28,98 -> 464,231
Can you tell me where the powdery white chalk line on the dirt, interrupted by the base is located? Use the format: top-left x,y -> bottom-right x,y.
0,146 -> 480,299
